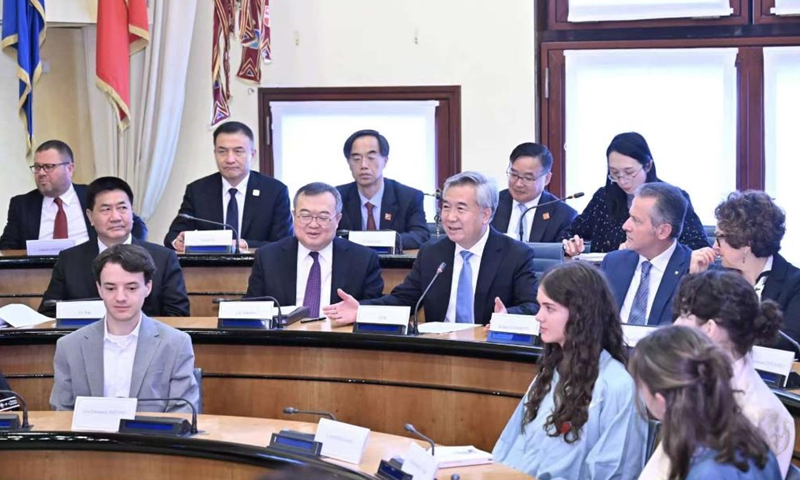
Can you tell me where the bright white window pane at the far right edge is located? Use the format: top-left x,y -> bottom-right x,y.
764,47 -> 800,264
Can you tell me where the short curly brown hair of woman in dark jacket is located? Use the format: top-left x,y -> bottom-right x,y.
714,190 -> 786,258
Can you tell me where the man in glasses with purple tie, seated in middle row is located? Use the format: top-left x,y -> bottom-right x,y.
245,182 -> 383,318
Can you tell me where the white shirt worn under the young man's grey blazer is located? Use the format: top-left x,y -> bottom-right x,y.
103,314 -> 142,398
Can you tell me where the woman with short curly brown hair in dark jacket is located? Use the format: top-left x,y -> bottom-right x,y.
690,190 -> 800,352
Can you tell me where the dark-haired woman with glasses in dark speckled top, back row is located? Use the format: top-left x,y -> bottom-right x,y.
563,132 -> 708,257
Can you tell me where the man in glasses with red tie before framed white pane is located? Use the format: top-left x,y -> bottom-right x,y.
336,130 -> 430,250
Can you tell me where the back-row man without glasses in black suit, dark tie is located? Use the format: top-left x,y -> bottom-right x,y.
164,122 -> 292,252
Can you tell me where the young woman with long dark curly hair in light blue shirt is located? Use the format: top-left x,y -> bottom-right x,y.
493,262 -> 647,480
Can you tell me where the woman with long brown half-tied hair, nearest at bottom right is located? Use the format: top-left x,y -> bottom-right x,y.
629,326 -> 783,480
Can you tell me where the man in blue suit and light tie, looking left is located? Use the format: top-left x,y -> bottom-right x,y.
600,182 -> 692,325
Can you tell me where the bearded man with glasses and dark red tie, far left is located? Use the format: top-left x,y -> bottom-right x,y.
0,140 -> 147,250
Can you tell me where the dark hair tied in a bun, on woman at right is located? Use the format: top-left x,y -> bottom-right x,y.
672,270 -> 783,356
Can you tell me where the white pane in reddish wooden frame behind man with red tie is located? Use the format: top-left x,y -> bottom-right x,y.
271,101 -> 438,221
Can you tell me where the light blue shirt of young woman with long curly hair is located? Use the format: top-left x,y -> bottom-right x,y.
492,350 -> 647,480
